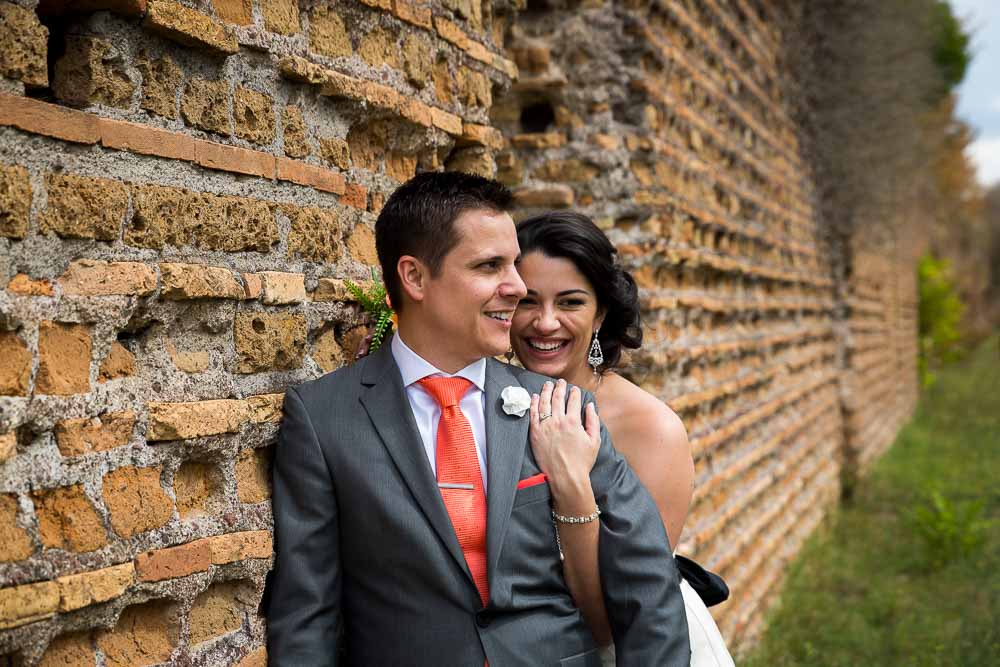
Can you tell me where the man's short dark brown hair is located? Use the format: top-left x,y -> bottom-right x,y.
375,171 -> 512,311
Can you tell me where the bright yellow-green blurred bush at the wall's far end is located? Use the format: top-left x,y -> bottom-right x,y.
917,254 -> 965,387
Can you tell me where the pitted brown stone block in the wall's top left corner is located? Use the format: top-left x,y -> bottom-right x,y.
0,2 -> 49,86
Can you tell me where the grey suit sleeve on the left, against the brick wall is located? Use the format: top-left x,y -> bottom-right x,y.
267,388 -> 341,667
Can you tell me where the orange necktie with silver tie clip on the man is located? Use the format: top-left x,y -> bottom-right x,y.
419,377 -> 490,606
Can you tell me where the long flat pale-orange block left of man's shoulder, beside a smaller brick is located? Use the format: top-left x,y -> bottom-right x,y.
146,400 -> 250,441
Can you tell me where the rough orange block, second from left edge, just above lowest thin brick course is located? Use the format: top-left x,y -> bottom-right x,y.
31,484 -> 108,553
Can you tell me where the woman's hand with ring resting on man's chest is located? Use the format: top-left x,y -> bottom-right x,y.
530,380 -> 601,506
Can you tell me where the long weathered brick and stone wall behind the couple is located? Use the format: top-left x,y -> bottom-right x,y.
0,0 -> 915,665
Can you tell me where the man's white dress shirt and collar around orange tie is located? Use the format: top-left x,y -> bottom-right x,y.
390,331 -> 487,491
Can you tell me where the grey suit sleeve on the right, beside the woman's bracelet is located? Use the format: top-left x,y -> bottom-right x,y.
585,396 -> 691,667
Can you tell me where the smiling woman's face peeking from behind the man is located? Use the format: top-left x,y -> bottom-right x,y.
510,251 -> 604,382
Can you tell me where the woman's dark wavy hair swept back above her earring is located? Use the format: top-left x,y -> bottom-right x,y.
517,211 -> 642,372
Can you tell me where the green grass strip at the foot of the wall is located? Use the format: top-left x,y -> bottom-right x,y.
739,336 -> 1000,667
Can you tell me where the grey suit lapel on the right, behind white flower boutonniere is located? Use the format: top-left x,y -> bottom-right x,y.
485,359 -> 530,581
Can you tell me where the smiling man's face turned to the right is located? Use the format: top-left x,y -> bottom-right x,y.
422,210 -> 526,372
